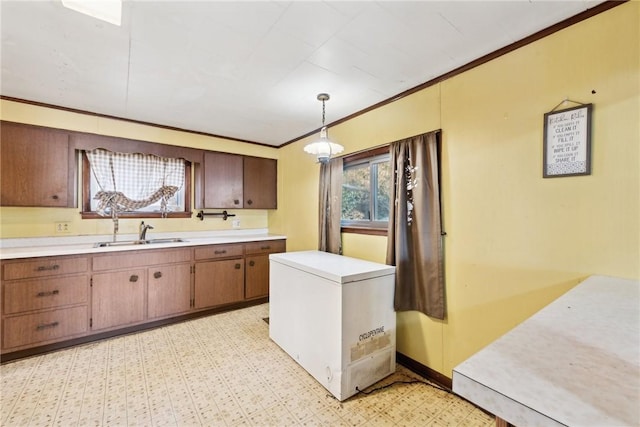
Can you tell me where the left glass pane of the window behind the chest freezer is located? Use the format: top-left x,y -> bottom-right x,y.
342,163 -> 371,220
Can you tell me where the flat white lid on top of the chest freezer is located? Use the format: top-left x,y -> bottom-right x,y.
269,251 -> 396,284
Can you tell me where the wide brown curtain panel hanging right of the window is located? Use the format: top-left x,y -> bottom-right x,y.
387,131 -> 446,319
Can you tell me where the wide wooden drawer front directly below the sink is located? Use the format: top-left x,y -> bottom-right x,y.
93,248 -> 191,271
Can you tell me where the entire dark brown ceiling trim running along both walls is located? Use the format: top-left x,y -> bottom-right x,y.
0,0 -> 629,149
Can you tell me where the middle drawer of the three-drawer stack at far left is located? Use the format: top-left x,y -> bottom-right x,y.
3,275 -> 89,314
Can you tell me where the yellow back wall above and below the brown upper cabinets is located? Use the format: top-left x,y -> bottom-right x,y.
0,100 -> 278,239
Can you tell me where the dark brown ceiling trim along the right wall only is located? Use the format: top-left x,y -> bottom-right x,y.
278,0 -> 629,148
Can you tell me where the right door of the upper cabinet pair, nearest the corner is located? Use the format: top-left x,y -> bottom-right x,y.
243,157 -> 278,209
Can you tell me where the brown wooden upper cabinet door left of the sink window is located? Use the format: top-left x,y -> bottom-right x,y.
0,122 -> 76,207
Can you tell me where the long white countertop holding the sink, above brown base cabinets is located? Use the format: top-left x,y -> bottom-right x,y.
0,229 -> 286,260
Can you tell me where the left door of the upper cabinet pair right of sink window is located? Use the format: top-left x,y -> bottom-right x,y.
203,151 -> 243,209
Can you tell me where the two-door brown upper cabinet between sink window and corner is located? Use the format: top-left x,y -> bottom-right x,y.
203,151 -> 277,209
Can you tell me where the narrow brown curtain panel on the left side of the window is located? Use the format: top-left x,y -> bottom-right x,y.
318,157 -> 342,255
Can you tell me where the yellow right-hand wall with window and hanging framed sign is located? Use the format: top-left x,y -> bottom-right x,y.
270,2 -> 640,377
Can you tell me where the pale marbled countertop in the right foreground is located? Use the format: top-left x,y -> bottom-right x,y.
453,276 -> 640,427
